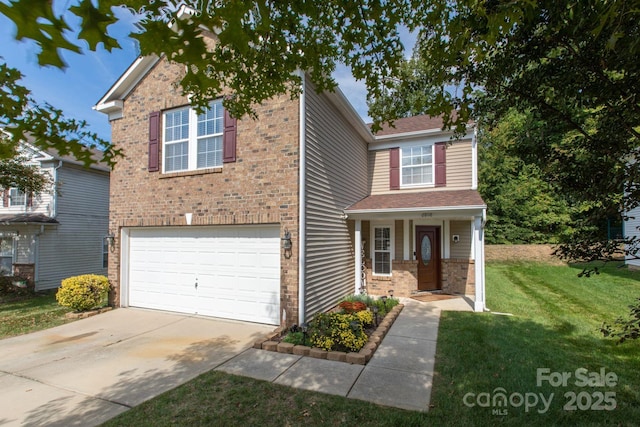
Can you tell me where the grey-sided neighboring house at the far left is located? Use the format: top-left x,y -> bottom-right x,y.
0,143 -> 109,291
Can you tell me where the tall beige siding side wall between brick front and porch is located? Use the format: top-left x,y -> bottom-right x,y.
305,77 -> 368,318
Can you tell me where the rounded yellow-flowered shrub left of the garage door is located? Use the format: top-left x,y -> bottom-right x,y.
56,274 -> 109,311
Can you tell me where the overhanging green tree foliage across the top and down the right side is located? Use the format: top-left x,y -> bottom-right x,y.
0,0 -> 640,266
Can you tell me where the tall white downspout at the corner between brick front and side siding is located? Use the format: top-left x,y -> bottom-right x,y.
298,71 -> 307,325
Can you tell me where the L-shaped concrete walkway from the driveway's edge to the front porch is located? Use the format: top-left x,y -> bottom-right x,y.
216,298 -> 472,411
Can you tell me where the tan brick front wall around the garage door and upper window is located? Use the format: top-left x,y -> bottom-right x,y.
109,58 -> 299,321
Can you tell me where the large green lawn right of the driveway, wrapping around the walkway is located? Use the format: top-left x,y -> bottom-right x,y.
99,263 -> 640,426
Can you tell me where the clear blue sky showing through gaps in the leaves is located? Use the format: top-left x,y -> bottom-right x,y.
0,9 -> 415,141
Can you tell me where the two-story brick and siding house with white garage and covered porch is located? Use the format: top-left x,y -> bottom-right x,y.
94,56 -> 486,325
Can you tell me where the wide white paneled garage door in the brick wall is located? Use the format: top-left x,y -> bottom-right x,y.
128,226 -> 280,325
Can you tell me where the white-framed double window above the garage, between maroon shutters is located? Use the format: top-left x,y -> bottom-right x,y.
162,100 -> 224,172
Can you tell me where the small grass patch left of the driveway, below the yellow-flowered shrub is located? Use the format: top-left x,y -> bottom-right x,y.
0,293 -> 71,339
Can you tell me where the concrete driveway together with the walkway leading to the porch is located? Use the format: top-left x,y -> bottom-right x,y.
0,298 -> 471,427
